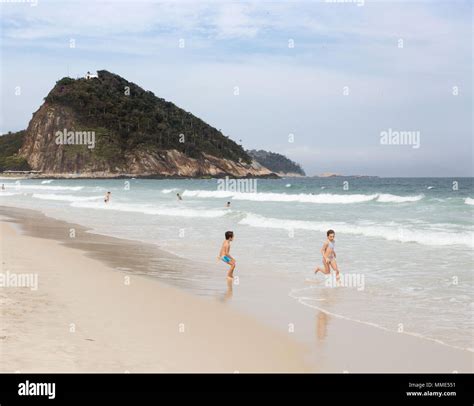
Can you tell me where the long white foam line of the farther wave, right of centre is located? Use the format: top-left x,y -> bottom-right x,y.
183,190 -> 424,204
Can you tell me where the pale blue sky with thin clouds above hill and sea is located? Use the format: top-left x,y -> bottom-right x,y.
0,0 -> 473,177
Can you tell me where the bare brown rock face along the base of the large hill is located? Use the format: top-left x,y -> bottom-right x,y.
19,102 -> 272,177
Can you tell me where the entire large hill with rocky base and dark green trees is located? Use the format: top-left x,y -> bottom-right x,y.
18,71 -> 275,177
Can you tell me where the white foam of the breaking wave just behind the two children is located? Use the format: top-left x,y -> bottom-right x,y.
239,213 -> 474,247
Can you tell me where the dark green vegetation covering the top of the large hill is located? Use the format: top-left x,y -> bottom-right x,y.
45,70 -> 251,163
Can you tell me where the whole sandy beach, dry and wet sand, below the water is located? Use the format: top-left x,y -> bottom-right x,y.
0,206 -> 474,373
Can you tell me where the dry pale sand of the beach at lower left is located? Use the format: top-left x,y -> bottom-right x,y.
0,211 -> 309,373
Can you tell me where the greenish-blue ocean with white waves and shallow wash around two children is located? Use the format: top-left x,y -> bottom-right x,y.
0,177 -> 474,351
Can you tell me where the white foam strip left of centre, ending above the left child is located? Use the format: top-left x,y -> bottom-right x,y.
71,201 -> 231,218
